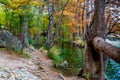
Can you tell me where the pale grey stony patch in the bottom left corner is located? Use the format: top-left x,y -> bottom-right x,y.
0,68 -> 38,80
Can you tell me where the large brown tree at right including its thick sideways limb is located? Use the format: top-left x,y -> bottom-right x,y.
84,0 -> 120,80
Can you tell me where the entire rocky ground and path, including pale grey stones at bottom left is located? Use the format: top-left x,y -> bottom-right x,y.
0,50 -> 84,80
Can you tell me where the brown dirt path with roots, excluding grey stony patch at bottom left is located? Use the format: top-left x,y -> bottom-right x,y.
0,50 -> 84,80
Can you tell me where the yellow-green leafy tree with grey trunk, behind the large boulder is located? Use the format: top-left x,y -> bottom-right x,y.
0,0 -> 44,48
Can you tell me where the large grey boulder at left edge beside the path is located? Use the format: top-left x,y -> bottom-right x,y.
0,30 -> 22,51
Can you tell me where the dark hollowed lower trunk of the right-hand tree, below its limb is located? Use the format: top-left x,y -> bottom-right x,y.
84,44 -> 104,80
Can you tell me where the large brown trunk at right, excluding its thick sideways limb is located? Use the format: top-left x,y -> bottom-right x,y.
84,0 -> 105,80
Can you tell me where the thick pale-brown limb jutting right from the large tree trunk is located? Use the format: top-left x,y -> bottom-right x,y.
93,37 -> 120,63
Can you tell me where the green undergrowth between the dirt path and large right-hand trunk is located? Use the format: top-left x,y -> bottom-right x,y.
48,44 -> 83,76
